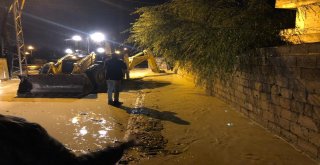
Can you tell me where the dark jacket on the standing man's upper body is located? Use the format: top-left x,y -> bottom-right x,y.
106,58 -> 127,80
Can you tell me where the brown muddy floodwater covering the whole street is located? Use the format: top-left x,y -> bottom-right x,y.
0,70 -> 317,165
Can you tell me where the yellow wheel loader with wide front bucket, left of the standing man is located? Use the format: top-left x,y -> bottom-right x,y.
17,53 -> 105,97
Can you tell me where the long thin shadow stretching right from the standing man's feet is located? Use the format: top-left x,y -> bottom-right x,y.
119,106 -> 190,125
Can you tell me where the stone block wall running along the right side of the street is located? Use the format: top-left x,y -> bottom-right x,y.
180,43 -> 320,160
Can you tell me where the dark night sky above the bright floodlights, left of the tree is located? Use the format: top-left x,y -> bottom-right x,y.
22,0 -> 168,50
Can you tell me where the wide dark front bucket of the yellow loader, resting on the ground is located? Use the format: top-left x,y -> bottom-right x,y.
17,74 -> 93,98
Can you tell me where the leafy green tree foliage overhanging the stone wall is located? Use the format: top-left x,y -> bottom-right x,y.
128,0 -> 294,80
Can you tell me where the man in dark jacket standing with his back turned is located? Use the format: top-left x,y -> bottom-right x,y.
105,54 -> 127,106
